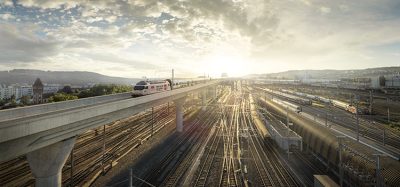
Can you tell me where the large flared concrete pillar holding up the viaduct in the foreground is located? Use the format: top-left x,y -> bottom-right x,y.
26,138 -> 75,187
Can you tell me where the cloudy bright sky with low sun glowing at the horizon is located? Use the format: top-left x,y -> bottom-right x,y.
0,0 -> 400,78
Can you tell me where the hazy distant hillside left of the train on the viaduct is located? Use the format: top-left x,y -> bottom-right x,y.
0,69 -> 139,85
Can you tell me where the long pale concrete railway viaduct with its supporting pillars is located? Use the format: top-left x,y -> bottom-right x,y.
0,80 -> 220,186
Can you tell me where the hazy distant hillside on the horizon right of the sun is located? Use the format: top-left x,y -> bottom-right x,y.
249,66 -> 400,79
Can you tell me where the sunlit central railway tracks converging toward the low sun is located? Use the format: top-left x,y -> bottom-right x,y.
191,87 -> 300,186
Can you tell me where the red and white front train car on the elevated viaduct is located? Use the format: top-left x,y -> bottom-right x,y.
132,79 -> 171,97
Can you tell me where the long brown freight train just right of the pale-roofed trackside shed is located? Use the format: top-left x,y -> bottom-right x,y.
261,100 -> 400,186
